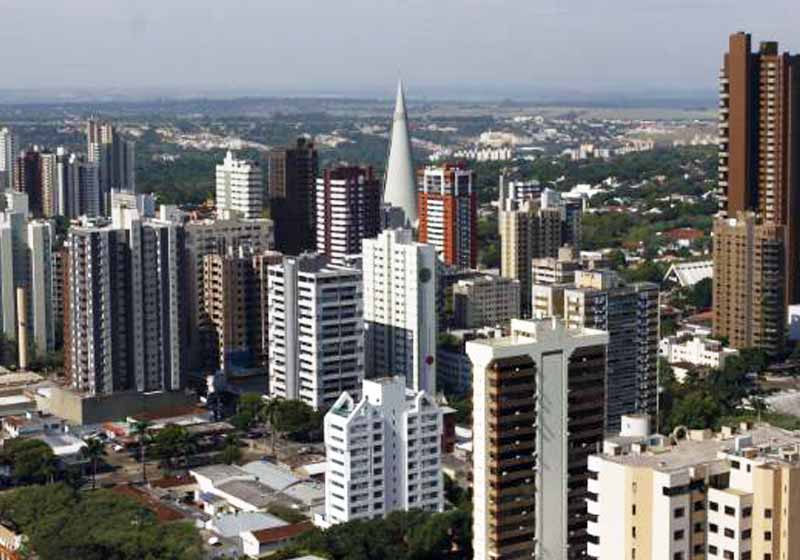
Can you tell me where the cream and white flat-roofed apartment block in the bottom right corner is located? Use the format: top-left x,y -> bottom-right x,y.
588,418 -> 800,560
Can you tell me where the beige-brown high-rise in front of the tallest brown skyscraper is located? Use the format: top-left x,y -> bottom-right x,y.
714,212 -> 785,352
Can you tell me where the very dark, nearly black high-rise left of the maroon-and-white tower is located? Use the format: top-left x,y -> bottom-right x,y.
267,137 -> 319,255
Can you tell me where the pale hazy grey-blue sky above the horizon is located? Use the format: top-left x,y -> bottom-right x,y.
0,0 -> 800,93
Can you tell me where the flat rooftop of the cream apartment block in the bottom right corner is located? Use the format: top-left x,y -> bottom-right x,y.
602,424 -> 800,473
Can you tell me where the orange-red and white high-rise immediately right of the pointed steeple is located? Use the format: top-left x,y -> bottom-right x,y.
418,164 -> 478,268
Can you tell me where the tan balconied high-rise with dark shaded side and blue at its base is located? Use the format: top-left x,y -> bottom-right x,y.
200,247 -> 282,372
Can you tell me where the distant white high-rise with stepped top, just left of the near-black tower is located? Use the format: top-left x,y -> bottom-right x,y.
216,151 -> 264,219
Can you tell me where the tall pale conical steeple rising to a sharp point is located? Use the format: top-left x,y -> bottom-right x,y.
383,80 -> 417,226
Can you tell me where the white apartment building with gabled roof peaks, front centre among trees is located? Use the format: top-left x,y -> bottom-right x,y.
316,377 -> 444,526
